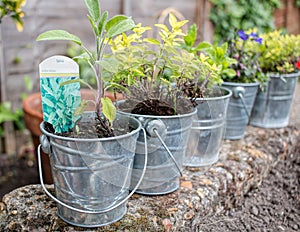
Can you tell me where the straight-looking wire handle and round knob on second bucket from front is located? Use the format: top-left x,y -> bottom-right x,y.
146,119 -> 182,176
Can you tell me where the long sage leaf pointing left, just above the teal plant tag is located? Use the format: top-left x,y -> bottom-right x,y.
36,30 -> 82,45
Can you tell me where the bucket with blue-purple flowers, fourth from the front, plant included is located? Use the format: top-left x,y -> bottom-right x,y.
222,29 -> 267,139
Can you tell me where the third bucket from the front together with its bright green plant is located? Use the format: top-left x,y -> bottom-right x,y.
182,24 -> 235,167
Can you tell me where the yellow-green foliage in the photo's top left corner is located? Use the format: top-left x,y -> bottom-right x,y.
0,0 -> 26,31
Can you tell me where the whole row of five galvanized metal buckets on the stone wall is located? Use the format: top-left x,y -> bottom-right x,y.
38,72 -> 298,227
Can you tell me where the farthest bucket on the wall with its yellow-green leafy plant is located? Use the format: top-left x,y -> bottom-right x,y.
250,30 -> 300,128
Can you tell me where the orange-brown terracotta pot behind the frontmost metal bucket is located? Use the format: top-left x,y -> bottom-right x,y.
23,89 -> 122,184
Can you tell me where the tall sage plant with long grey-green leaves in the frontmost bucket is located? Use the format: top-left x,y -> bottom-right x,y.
37,0 -> 135,126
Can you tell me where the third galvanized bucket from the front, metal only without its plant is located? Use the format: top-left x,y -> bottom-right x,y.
183,88 -> 232,167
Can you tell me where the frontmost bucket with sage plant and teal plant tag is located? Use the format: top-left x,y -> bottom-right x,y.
37,0 -> 147,227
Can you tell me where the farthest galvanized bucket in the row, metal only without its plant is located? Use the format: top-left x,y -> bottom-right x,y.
250,73 -> 300,128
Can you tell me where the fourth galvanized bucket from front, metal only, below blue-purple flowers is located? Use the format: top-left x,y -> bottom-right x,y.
222,82 -> 259,140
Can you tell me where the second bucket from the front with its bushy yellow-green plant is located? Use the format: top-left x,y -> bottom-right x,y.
103,14 -> 218,195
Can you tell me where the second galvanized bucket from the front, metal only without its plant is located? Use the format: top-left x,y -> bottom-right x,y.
121,109 -> 197,195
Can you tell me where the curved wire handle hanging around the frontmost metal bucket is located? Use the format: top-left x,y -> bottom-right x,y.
38,128 -> 148,214
